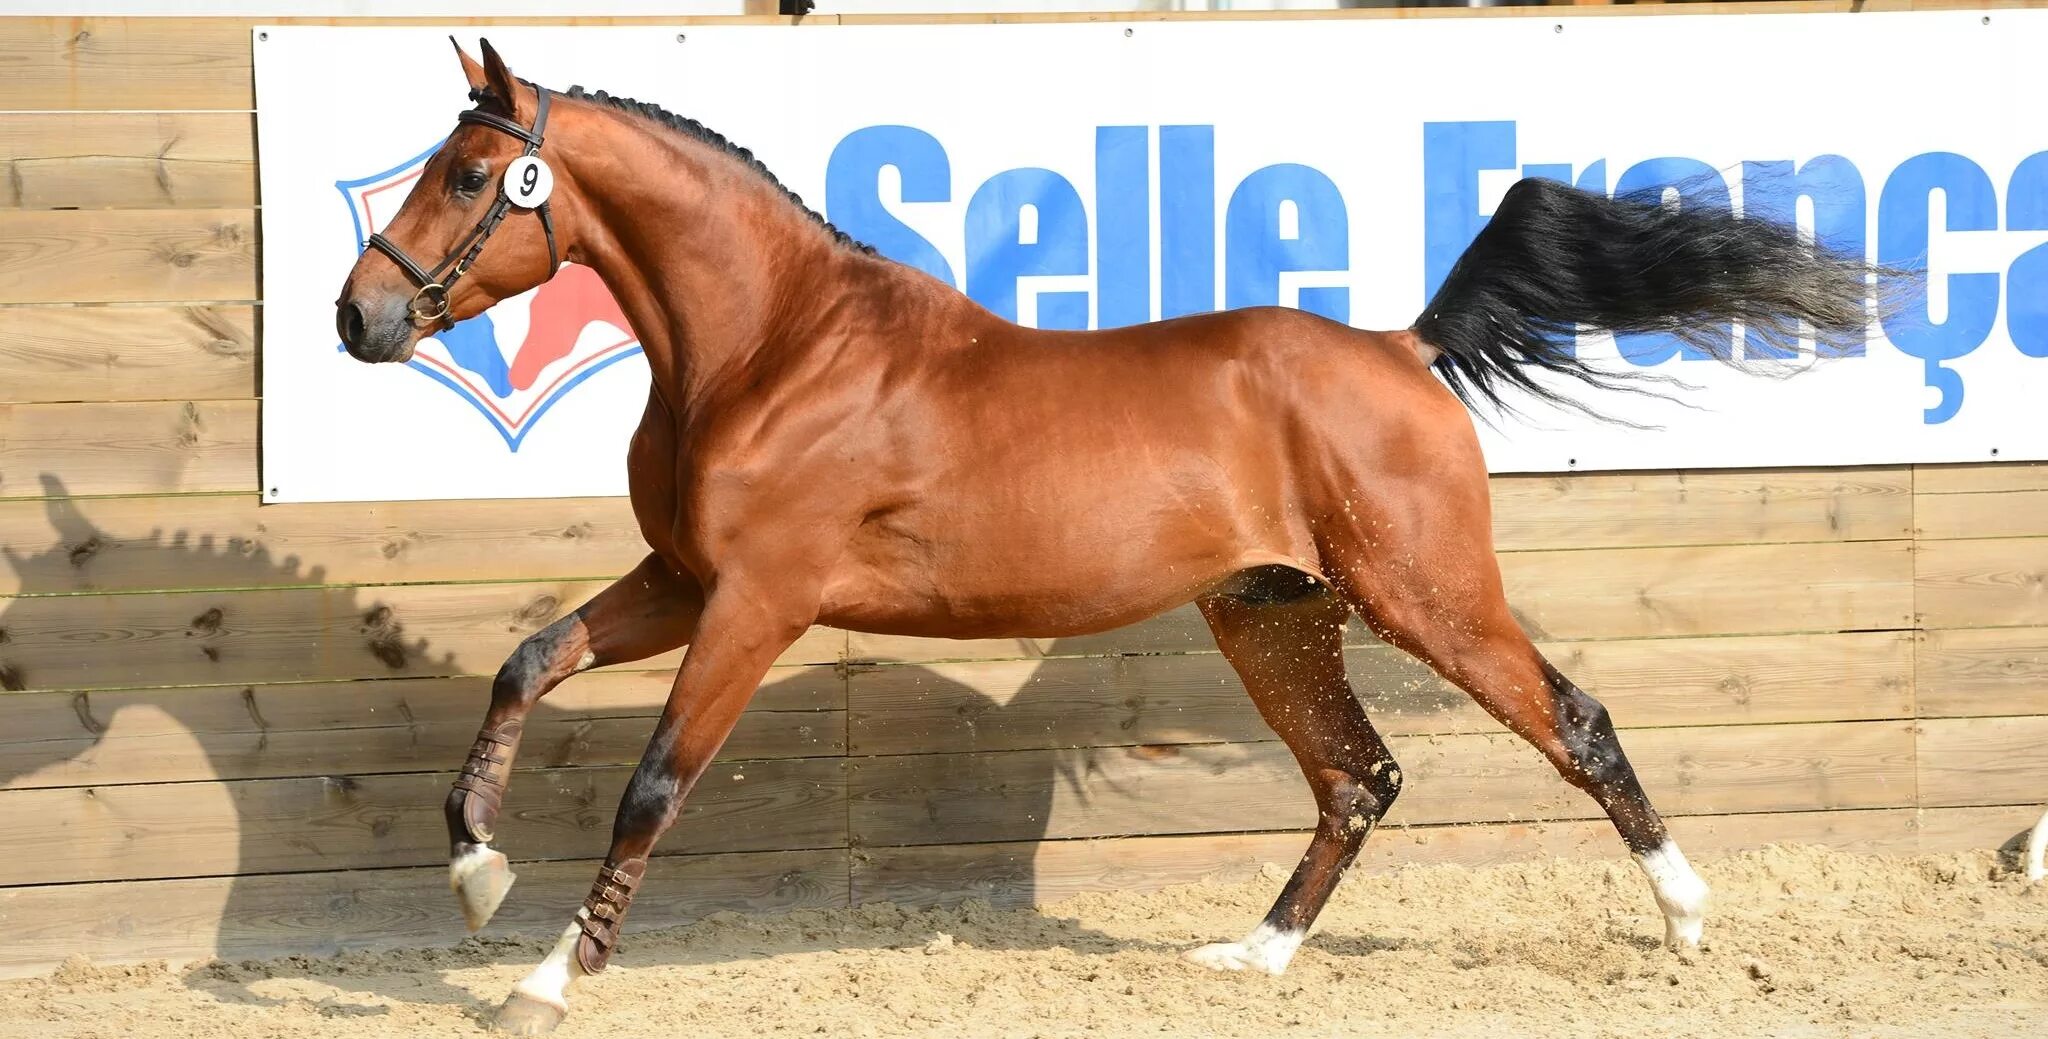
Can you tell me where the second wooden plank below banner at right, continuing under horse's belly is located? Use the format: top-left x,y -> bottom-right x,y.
848,541 -> 1913,662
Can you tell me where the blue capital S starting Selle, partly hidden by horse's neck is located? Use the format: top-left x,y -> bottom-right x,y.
825,125 -> 958,287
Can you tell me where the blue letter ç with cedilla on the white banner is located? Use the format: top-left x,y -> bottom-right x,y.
1878,152 -> 1999,424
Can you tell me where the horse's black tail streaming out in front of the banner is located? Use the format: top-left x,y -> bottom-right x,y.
1413,178 -> 1876,414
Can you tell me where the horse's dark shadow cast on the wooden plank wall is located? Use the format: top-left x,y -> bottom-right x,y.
0,475 -> 1376,1000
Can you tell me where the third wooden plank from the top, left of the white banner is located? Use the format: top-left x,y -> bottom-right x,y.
0,209 -> 258,303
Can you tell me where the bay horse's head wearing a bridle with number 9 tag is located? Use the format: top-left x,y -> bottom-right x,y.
334,41 -> 567,363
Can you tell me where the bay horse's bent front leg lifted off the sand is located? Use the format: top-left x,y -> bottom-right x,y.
444,555 -> 702,930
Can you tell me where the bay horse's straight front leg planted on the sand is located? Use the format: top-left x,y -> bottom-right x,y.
498,580 -> 817,1035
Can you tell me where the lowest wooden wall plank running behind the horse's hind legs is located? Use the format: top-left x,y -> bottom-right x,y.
852,807 -> 1919,908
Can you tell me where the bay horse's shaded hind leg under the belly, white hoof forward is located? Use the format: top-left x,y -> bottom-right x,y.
1188,586 -> 1401,973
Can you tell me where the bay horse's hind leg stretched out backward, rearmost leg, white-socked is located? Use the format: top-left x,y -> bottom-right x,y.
1335,532 -> 1708,949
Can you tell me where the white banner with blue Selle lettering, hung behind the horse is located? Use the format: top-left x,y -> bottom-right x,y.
252,10 -> 2048,500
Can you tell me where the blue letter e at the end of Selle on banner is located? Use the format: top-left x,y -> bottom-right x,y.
1223,164 -> 1352,322
